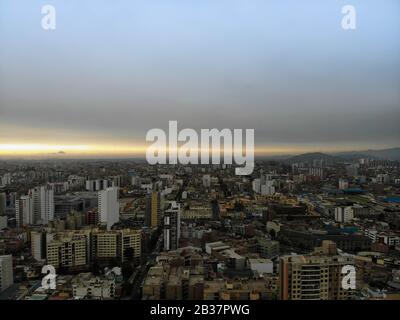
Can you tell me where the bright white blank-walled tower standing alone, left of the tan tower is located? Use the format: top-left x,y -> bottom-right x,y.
98,187 -> 119,230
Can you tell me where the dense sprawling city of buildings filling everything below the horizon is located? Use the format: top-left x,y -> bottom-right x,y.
0,149 -> 400,300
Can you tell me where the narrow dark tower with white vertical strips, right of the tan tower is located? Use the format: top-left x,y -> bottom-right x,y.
163,201 -> 181,251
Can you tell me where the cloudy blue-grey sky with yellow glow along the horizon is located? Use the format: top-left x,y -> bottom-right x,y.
0,0 -> 400,157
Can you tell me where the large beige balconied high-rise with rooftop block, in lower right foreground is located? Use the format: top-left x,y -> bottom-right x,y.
279,241 -> 355,300
